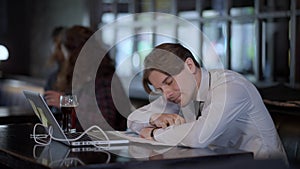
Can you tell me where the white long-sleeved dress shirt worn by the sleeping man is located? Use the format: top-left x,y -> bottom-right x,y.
128,69 -> 286,160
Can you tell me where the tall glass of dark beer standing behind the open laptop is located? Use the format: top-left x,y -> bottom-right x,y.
60,95 -> 78,133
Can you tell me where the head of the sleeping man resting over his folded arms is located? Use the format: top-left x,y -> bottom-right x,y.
143,43 -> 200,106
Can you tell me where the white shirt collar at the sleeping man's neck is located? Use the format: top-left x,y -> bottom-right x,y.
196,68 -> 211,101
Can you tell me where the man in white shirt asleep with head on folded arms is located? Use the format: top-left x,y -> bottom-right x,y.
127,43 -> 286,160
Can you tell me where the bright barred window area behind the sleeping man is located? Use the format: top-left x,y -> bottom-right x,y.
94,0 -> 300,97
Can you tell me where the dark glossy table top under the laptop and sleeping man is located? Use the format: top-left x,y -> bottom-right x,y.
0,109 -> 286,169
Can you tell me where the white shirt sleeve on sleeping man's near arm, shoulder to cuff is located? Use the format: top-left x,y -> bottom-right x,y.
155,82 -> 249,147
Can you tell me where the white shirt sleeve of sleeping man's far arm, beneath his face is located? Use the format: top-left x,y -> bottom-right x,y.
127,96 -> 179,133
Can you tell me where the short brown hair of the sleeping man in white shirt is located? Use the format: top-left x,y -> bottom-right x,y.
143,43 -> 200,93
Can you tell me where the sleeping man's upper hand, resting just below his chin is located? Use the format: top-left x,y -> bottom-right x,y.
150,113 -> 185,128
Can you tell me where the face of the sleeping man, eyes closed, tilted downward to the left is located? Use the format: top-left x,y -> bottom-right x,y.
149,65 -> 197,107
